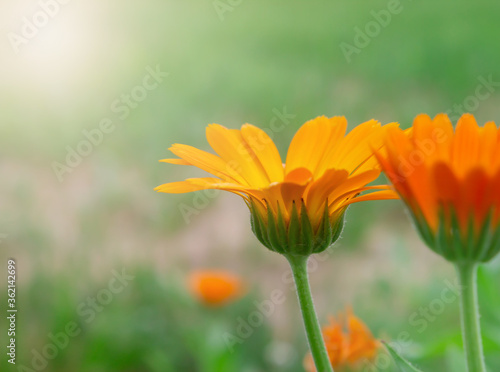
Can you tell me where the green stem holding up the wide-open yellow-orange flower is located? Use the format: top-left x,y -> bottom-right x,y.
286,255 -> 333,372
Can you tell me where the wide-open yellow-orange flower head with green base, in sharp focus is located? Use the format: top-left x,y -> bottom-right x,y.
155,116 -> 397,255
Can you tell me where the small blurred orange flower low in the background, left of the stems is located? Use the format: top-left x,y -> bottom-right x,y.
188,270 -> 244,306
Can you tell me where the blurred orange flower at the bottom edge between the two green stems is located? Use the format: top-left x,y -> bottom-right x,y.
304,310 -> 380,372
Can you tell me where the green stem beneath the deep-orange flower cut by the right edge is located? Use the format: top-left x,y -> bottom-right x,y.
456,262 -> 486,372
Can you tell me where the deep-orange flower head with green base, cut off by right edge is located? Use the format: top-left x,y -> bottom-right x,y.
377,114 -> 500,261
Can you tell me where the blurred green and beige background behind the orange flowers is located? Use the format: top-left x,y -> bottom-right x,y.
0,0 -> 500,372
